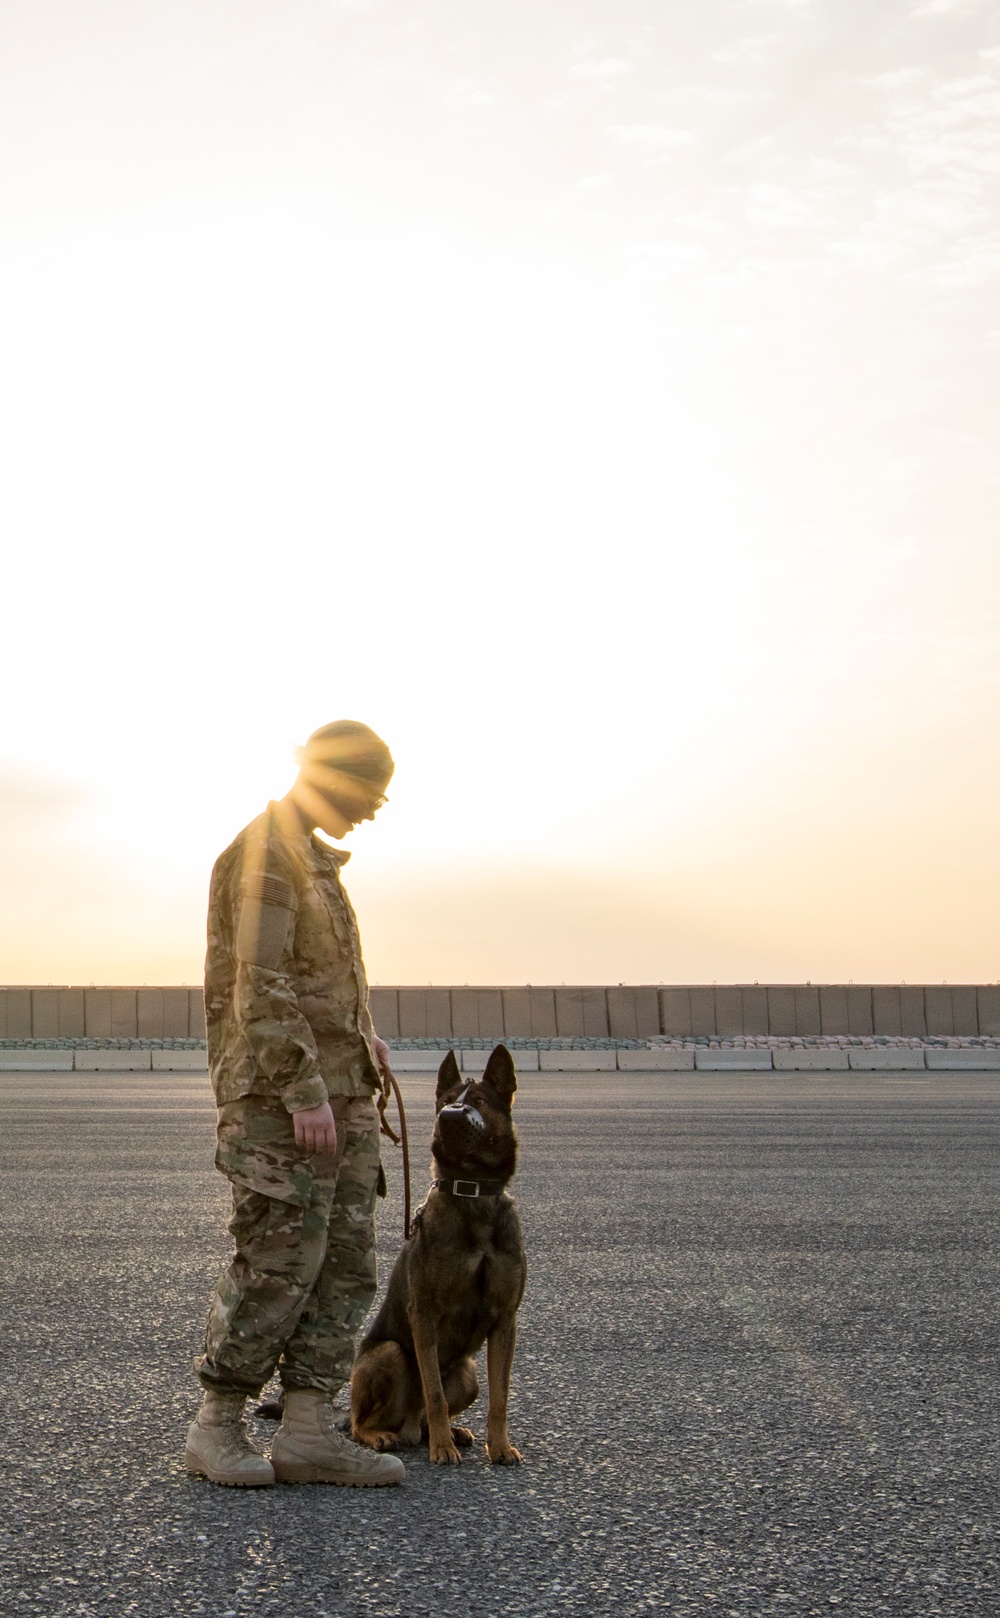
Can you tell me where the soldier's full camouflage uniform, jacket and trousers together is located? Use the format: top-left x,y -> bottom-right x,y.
199,804 -> 380,1393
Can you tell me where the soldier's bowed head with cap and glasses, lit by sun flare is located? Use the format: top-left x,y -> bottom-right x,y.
288,718 -> 395,837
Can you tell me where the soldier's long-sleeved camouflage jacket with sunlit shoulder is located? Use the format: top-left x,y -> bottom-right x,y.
206,803 -> 380,1112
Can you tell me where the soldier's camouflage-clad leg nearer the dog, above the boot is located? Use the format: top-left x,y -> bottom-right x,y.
280,1095 -> 379,1395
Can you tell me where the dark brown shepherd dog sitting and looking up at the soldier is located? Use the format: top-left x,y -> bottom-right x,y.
351,1045 -> 528,1464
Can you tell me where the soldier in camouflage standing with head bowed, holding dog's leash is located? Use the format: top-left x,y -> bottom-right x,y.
184,720 -> 403,1485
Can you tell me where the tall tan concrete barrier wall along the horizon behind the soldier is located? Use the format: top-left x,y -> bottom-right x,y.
0,984 -> 1000,1040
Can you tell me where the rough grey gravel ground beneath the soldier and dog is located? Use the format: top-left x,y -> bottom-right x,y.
0,1074 -> 1000,1618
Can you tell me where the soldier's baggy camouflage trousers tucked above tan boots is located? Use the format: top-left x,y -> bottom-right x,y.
197,1095 -> 379,1393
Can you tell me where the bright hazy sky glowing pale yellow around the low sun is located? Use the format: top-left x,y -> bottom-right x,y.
0,0 -> 1000,984
